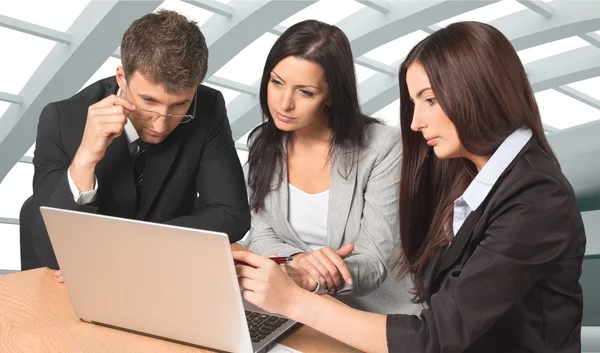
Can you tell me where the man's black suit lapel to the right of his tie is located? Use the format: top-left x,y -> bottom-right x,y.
136,131 -> 180,219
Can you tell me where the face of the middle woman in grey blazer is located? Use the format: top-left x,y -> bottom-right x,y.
267,56 -> 330,131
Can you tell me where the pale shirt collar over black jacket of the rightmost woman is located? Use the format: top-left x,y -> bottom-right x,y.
452,129 -> 533,236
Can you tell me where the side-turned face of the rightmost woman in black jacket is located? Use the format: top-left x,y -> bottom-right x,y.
406,63 -> 464,159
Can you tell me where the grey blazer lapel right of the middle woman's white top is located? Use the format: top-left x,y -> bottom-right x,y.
327,147 -> 358,250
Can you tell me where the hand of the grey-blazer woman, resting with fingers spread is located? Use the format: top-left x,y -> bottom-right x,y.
291,243 -> 354,294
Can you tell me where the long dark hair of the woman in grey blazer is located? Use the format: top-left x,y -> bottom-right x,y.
248,20 -> 374,211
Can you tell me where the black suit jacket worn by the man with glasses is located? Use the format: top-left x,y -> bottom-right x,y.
33,77 -> 250,268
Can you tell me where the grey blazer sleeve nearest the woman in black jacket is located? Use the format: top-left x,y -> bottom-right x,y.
338,131 -> 402,296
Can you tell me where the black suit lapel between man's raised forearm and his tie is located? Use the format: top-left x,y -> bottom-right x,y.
96,134 -> 137,218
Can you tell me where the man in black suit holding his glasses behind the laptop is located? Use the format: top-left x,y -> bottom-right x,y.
33,10 -> 250,281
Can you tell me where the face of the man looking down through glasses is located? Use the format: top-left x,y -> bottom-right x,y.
117,66 -> 196,144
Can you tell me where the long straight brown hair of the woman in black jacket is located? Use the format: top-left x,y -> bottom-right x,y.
398,22 -> 558,302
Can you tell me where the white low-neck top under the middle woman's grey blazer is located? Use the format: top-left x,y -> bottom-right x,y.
288,184 -> 329,251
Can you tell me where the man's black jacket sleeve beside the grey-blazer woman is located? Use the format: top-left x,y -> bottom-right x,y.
166,92 -> 250,243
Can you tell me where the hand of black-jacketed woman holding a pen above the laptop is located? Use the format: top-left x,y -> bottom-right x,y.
232,251 -> 305,317
